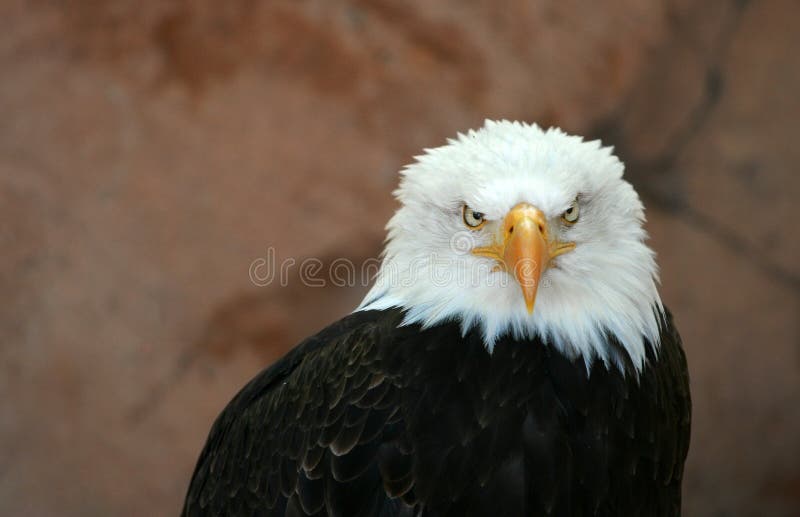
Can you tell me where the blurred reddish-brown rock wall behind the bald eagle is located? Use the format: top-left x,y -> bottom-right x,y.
0,0 -> 800,516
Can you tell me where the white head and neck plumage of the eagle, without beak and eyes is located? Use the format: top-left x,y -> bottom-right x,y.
357,120 -> 663,370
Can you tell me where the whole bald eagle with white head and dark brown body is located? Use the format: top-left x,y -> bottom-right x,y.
183,121 -> 691,517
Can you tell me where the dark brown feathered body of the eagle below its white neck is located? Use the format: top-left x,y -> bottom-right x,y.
183,310 -> 691,517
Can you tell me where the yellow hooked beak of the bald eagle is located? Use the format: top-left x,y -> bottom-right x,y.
472,203 -> 575,314
